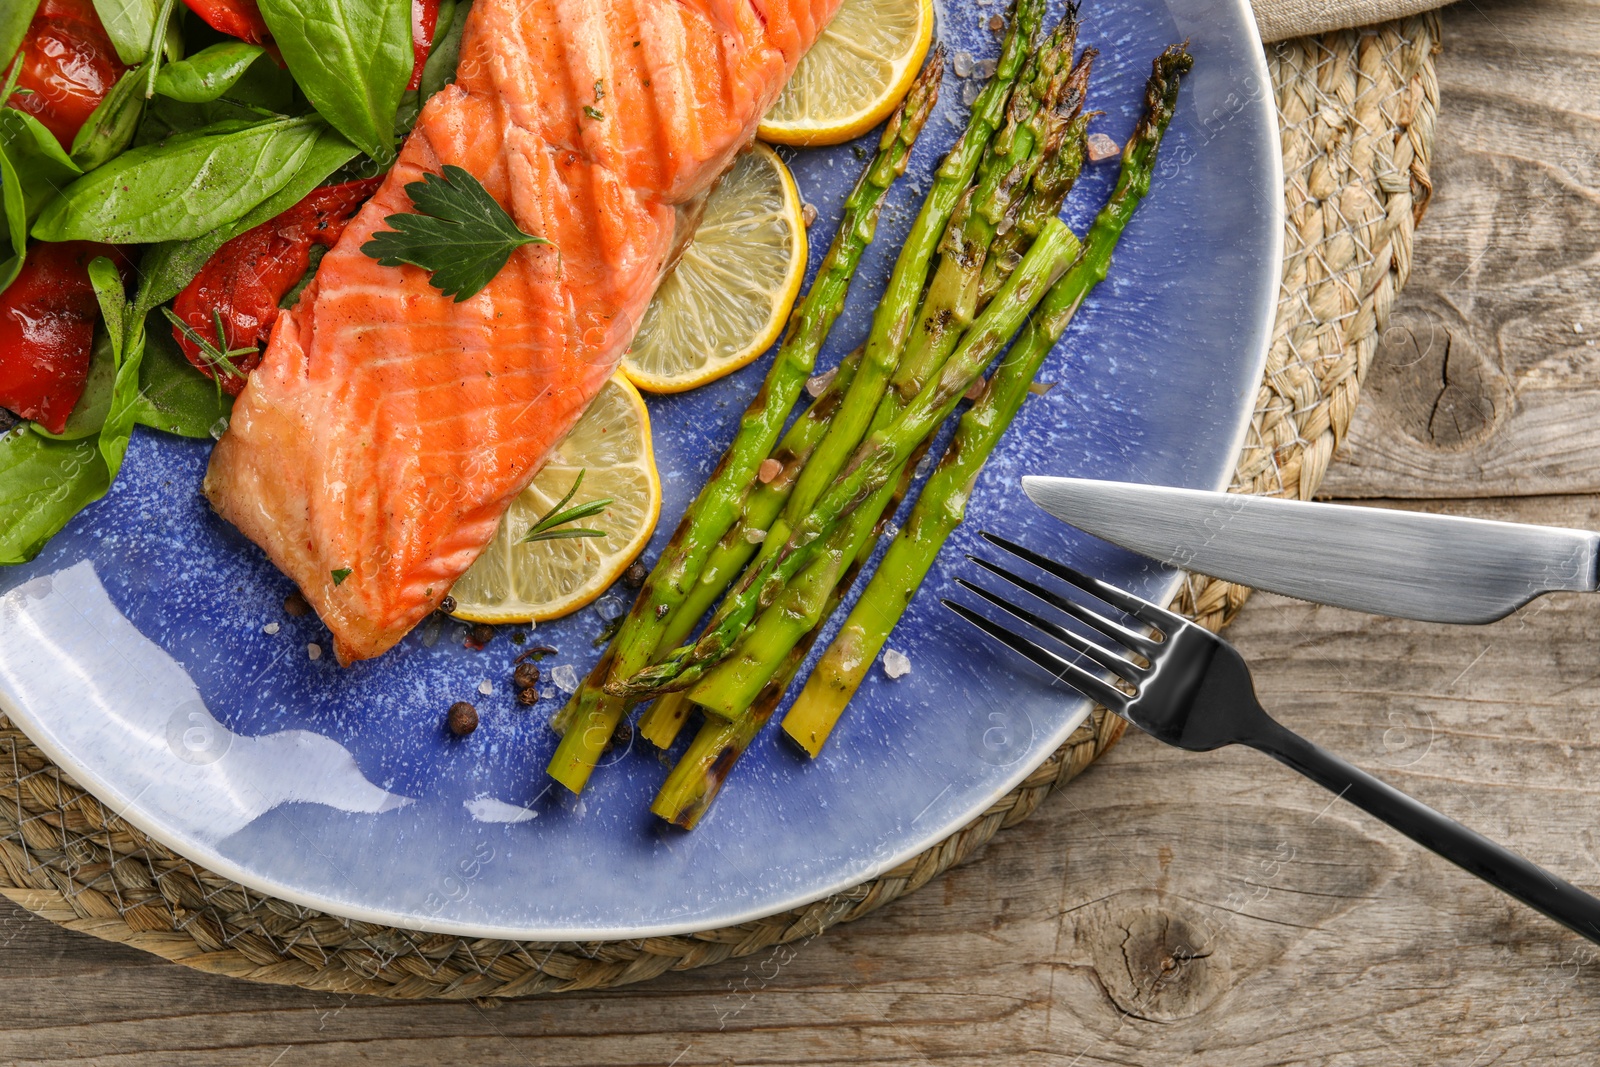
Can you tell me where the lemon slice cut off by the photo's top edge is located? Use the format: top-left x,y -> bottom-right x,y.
760,0 -> 933,144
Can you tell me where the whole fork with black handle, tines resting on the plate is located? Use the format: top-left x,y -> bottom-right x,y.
942,533 -> 1600,942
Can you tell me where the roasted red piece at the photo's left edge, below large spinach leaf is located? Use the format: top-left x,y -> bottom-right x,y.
0,242 -> 126,434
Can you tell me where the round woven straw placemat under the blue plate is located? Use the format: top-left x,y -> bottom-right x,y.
0,16 -> 1438,998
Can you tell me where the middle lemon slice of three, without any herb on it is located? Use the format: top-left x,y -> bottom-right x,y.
622,144 -> 806,392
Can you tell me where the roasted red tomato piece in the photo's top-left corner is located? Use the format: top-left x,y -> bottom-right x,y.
10,0 -> 128,147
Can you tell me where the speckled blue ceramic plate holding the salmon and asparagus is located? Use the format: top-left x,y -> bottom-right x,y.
0,0 -> 1282,939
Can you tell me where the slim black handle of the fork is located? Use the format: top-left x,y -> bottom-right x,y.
1240,715 -> 1600,944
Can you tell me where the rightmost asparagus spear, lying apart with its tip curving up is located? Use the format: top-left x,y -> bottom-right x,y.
784,46 -> 1194,757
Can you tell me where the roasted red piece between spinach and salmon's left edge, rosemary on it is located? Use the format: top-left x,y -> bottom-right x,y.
173,178 -> 382,397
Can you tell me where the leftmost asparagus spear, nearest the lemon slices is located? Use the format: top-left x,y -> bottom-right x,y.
547,58 -> 944,793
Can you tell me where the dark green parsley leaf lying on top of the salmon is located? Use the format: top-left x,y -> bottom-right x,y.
362,163 -> 550,304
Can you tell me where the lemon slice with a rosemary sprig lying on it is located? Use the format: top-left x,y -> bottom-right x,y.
450,374 -> 661,624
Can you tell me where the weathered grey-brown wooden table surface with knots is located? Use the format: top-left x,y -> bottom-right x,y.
12,0 -> 1600,1067
